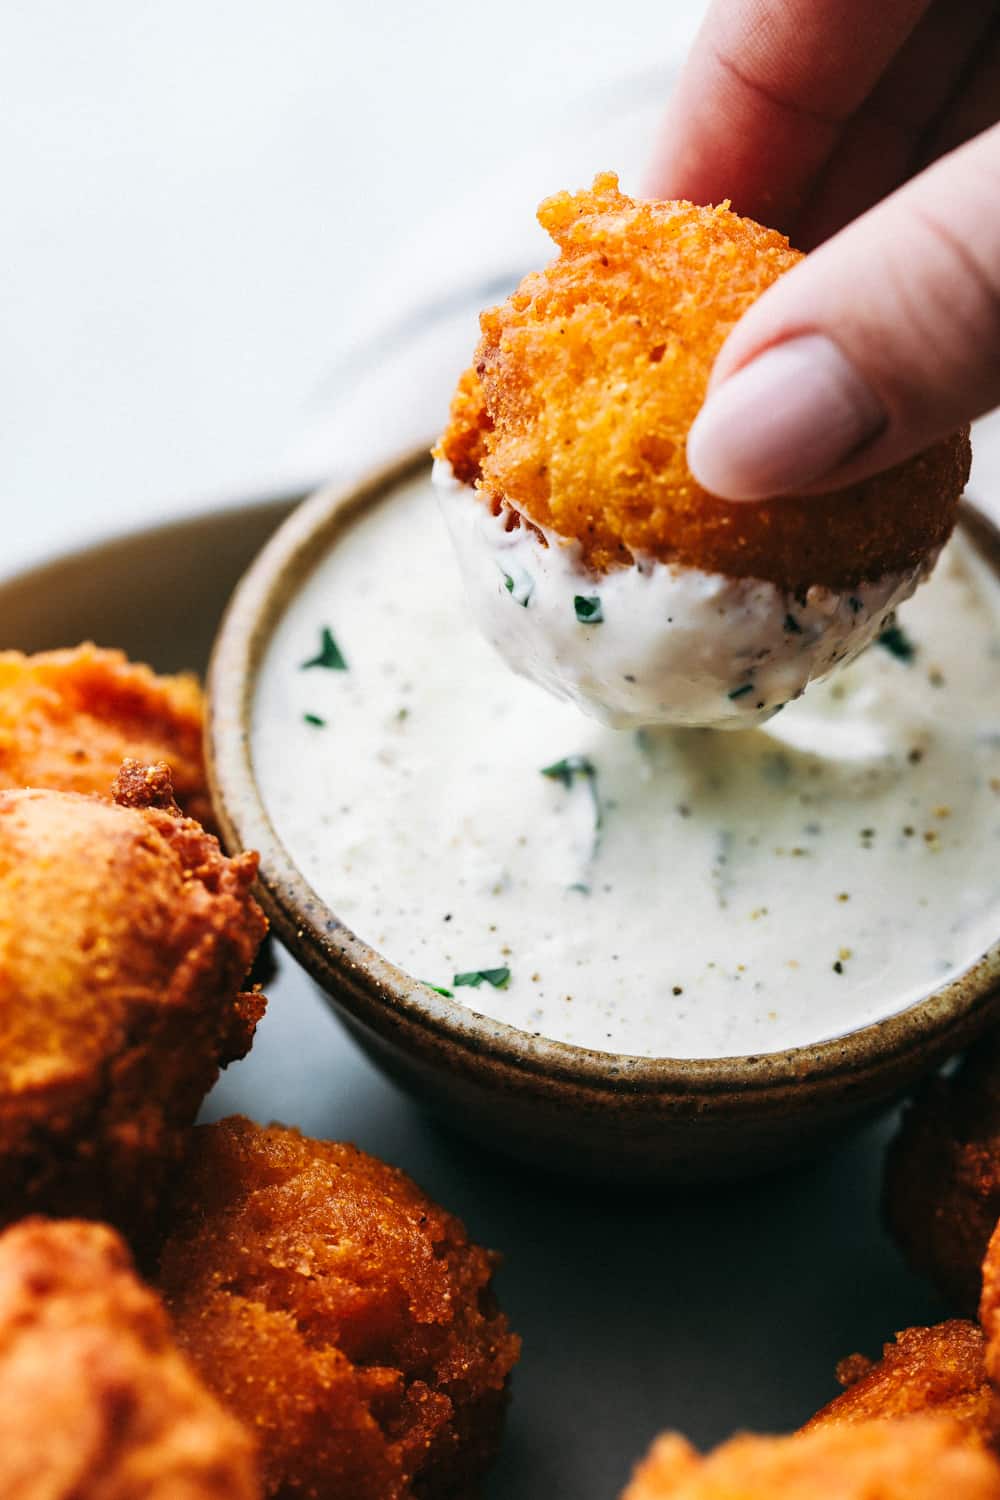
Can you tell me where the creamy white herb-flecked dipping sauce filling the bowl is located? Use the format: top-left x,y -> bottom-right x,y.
253,479 -> 1000,1058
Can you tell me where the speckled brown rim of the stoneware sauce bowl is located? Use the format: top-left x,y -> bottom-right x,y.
205,447 -> 1000,1095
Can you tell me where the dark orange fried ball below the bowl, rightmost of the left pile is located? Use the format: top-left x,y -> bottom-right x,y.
160,1118 -> 519,1500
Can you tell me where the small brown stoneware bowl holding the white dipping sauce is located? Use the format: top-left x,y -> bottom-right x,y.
208,453 -> 1000,1182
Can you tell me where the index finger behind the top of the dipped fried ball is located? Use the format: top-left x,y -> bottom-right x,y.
646,0 -> 930,228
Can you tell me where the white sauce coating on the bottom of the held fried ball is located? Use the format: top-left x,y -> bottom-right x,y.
433,459 -> 934,729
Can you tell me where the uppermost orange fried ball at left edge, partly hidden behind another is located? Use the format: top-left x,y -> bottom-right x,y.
0,642 -> 214,831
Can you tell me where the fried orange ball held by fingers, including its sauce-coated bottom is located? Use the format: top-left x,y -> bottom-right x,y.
435,174 -> 970,729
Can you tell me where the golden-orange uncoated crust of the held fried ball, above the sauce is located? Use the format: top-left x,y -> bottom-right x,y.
435,173 -> 970,590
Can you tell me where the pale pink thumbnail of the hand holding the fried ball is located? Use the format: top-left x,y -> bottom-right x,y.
688,333 -> 886,500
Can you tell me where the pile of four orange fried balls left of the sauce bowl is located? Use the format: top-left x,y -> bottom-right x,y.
0,645 -> 519,1500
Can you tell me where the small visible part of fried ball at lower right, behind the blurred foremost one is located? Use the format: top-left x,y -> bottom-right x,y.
802,1319 -> 1000,1448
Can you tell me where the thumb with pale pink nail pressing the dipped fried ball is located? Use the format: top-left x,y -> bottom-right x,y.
688,126 -> 1000,500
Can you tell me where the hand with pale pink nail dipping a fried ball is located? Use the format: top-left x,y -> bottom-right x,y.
648,0 -> 1000,500
